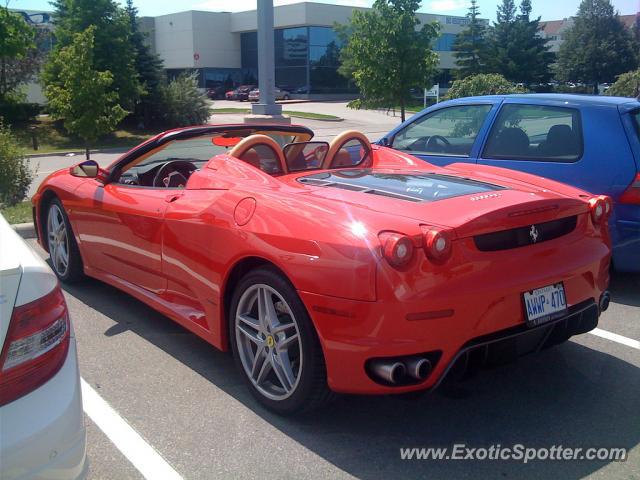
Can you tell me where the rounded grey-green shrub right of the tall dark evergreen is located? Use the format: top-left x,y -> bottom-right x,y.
163,73 -> 210,127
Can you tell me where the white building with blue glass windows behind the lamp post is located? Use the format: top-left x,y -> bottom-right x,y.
141,2 -> 468,96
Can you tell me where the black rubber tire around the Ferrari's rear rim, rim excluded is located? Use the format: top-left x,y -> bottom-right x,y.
228,267 -> 333,415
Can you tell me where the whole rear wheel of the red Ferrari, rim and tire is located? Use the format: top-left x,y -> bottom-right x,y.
230,268 -> 331,414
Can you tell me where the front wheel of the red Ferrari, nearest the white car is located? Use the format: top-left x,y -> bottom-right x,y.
46,198 -> 84,282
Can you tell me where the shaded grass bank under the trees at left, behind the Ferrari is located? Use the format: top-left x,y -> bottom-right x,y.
11,117 -> 158,154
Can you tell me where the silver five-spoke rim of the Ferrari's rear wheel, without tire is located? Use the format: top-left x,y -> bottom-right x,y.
235,284 -> 303,400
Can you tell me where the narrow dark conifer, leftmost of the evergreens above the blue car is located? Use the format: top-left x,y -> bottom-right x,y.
453,0 -> 486,78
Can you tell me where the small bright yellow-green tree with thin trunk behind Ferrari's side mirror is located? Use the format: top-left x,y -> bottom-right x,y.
45,26 -> 127,160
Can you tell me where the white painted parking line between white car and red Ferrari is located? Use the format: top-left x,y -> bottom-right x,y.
80,378 -> 182,480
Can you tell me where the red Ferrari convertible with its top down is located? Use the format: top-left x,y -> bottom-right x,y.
33,125 -> 611,413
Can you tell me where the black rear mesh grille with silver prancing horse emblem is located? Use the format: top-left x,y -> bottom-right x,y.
473,216 -> 578,252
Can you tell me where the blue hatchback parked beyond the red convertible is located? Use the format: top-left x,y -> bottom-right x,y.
378,94 -> 640,272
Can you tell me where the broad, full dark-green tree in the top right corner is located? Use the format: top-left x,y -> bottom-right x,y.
558,0 -> 638,92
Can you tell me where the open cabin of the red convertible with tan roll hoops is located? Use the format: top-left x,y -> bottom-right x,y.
116,131 -> 371,188
